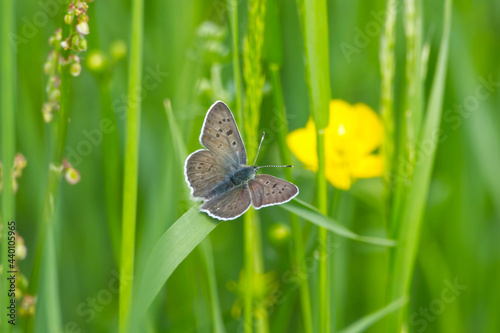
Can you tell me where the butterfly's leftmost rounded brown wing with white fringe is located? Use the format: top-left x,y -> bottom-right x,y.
184,149 -> 229,199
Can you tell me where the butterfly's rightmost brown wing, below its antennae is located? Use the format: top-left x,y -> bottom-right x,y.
248,175 -> 299,209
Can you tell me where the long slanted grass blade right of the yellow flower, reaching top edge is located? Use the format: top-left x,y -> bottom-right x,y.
392,0 -> 451,328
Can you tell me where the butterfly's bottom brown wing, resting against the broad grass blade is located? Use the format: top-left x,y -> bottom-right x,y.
200,186 -> 251,220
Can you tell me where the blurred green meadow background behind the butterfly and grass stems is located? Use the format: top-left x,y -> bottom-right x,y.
2,0 -> 500,332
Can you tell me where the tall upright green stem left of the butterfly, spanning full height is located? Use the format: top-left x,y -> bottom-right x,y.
118,0 -> 144,333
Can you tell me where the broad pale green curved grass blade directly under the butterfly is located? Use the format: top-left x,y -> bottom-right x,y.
132,205 -> 218,327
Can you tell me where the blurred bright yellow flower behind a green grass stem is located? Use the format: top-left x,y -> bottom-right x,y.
287,99 -> 384,190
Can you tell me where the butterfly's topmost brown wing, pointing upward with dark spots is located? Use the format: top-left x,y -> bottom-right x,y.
200,101 -> 247,170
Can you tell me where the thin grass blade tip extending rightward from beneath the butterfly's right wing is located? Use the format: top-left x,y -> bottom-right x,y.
280,199 -> 396,246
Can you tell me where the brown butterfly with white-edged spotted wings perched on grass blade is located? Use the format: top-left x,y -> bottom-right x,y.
184,101 -> 299,220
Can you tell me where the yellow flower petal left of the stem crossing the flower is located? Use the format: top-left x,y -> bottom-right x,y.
286,120 -> 318,171
